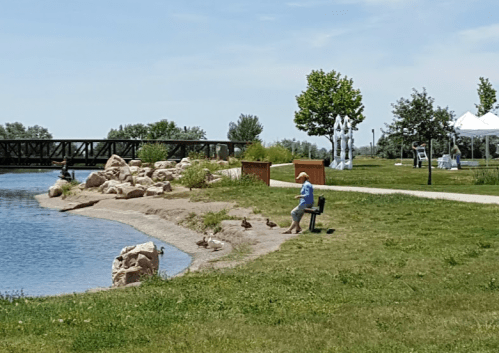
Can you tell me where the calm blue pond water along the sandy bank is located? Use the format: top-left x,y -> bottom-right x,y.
0,170 -> 191,296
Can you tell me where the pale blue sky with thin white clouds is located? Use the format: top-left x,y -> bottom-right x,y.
0,0 -> 499,149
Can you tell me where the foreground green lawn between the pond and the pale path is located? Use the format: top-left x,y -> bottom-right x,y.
0,176 -> 499,353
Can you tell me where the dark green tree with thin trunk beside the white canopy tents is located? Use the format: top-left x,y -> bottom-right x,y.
388,88 -> 454,185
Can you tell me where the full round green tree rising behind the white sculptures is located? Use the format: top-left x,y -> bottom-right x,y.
294,69 -> 365,160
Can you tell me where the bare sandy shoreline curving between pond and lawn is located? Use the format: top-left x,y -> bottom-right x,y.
36,188 -> 296,290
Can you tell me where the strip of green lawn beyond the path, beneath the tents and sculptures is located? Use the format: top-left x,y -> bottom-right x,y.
270,157 -> 499,196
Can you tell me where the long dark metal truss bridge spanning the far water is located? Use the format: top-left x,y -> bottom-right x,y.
0,139 -> 251,169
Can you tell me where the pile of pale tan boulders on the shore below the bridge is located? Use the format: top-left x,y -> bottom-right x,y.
49,154 -> 229,199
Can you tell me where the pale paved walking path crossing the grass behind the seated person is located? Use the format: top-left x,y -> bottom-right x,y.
219,163 -> 499,205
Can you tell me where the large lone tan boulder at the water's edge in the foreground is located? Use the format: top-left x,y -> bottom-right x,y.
112,241 -> 159,287
